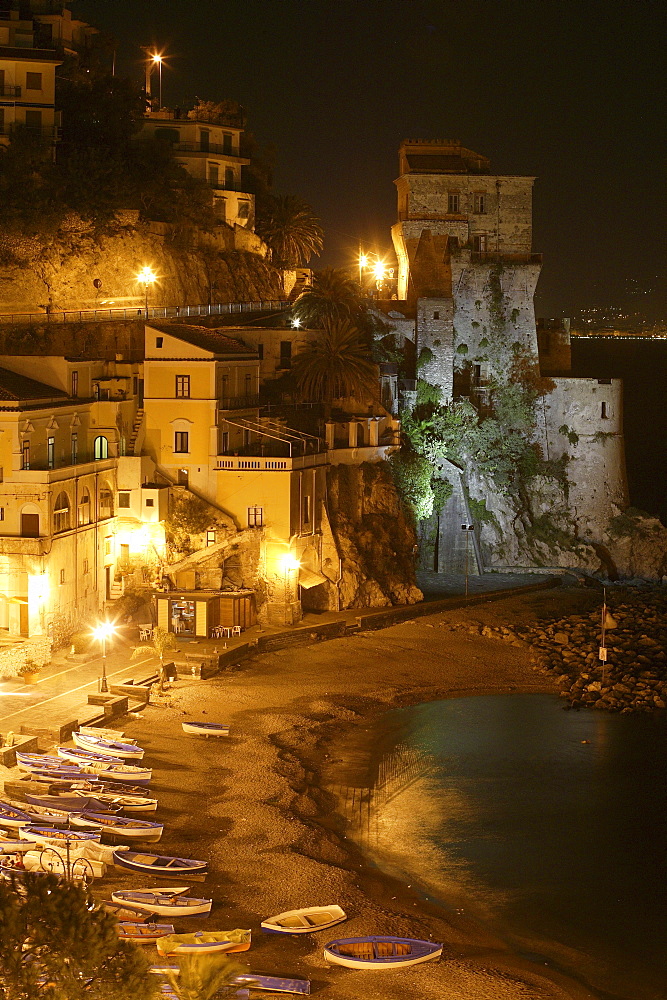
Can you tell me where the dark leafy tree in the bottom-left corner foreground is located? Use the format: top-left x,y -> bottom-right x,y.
0,872 -> 156,1000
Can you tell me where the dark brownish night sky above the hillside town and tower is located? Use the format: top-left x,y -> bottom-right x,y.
73,0 -> 667,319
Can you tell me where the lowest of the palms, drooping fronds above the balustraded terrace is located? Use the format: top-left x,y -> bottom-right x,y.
292,319 -> 378,403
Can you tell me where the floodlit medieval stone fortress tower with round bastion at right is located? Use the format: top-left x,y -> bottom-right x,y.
392,141 -> 628,571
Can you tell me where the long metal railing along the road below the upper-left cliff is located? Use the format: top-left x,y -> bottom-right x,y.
0,299 -> 289,324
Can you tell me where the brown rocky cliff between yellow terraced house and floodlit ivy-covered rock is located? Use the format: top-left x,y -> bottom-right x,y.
317,462 -> 423,608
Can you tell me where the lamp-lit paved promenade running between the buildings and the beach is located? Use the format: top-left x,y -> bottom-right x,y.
0,573 -> 550,734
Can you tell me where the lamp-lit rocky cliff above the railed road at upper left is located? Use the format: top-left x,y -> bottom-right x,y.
0,219 -> 282,313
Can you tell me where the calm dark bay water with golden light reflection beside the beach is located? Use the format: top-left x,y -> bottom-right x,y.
337,694 -> 667,1000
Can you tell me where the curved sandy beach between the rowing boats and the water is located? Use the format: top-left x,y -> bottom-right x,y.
115,588 -> 598,1000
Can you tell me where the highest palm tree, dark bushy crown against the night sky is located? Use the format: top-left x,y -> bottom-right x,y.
255,194 -> 324,268
